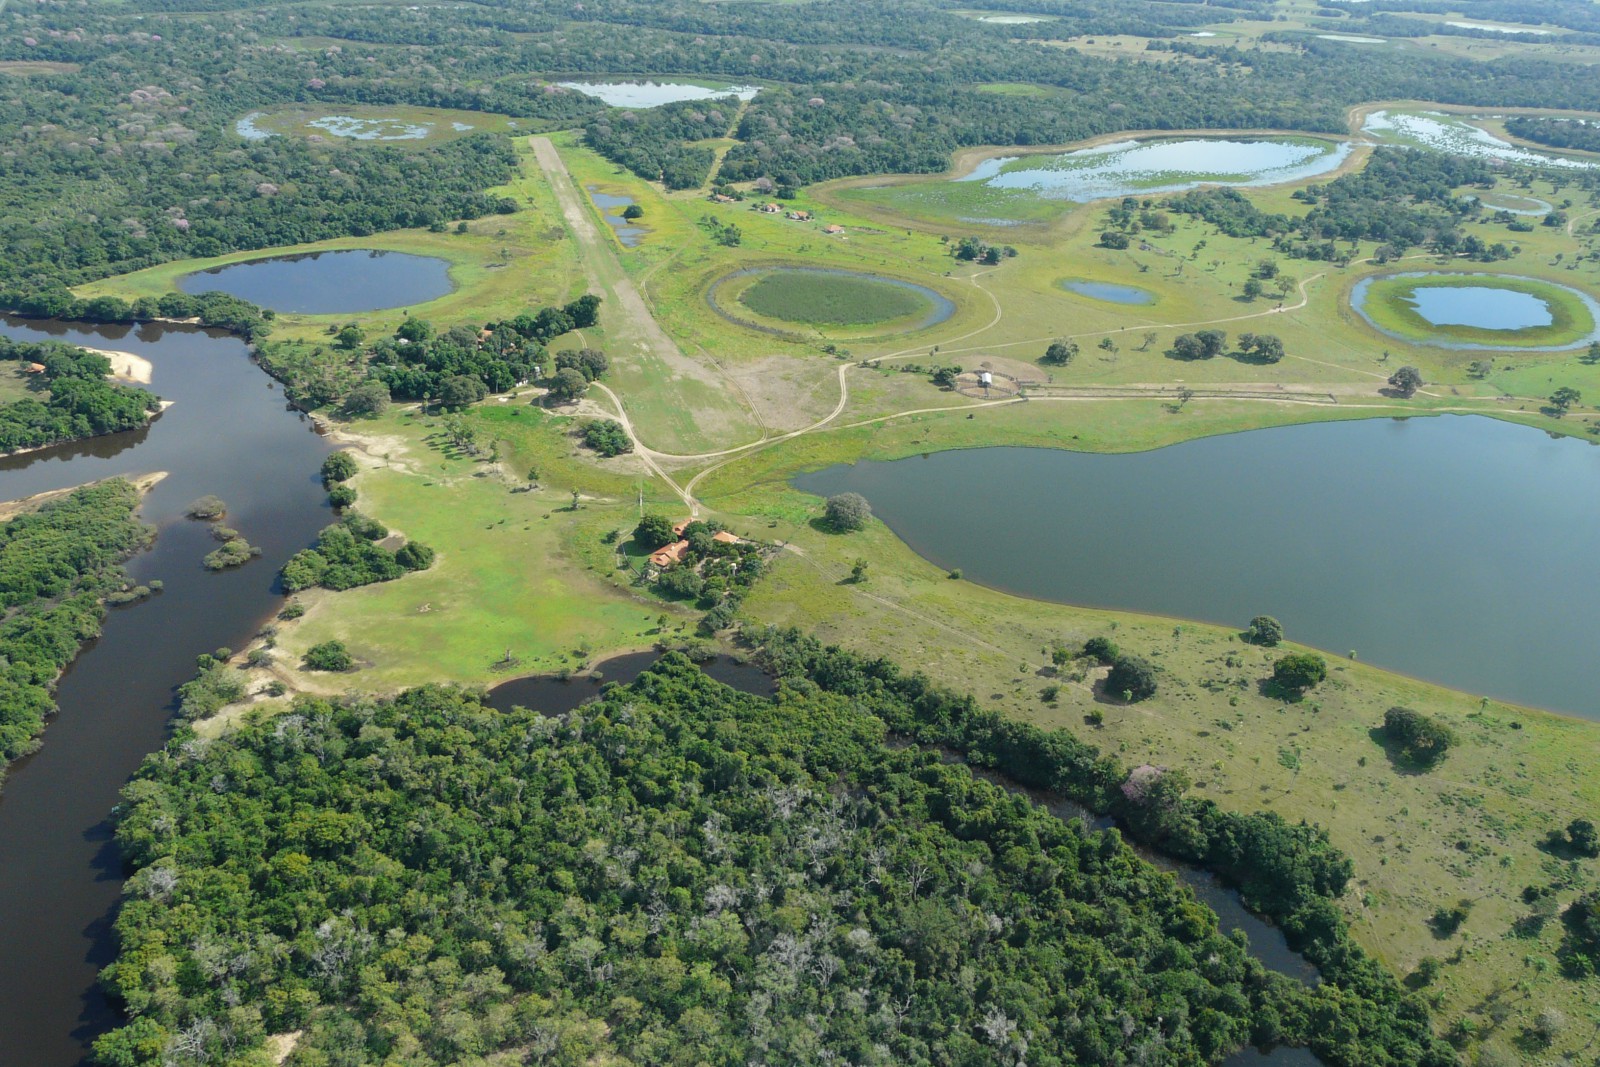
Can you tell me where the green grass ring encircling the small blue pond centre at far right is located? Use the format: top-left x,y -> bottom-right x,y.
1360,270 -> 1595,349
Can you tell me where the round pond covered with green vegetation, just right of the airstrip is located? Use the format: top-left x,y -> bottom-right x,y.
706,267 -> 955,333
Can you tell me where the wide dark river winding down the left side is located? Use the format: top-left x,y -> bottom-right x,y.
0,313 -> 333,1067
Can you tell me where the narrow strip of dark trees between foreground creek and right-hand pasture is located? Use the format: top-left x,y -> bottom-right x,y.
758,629 -> 1458,1067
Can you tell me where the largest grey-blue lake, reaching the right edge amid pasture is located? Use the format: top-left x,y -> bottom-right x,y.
795,416 -> 1600,718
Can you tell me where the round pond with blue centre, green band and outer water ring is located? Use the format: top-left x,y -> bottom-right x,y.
1350,272 -> 1600,352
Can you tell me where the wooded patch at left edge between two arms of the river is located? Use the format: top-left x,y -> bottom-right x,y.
0,338 -> 162,454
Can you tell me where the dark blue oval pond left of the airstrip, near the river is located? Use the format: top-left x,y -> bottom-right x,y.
178,248 -> 453,315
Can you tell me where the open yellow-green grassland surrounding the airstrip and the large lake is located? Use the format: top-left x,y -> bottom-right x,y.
85,106 -> 1600,1057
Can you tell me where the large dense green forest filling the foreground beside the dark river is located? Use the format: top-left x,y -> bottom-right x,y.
96,656 -> 1331,1067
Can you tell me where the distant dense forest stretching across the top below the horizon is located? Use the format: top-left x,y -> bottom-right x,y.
0,0 -> 1600,281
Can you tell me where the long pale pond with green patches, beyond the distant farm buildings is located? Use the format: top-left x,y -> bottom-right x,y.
955,138 -> 1350,203
